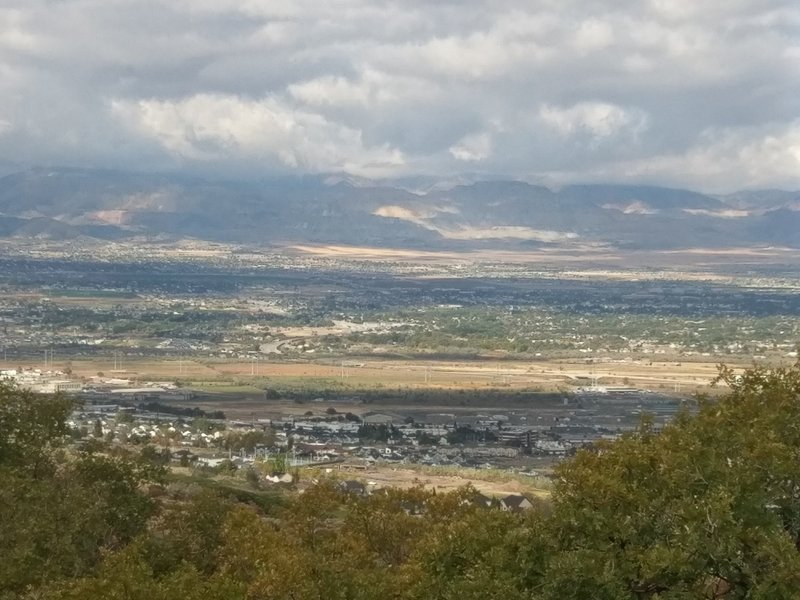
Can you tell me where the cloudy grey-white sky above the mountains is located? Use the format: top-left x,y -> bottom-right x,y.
0,0 -> 800,192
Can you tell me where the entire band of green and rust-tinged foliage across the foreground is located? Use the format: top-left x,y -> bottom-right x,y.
0,367 -> 800,600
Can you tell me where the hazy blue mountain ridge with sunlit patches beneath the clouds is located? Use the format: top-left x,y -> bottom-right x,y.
0,169 -> 800,249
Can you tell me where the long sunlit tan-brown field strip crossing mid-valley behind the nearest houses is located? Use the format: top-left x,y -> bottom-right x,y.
4,357 -> 746,393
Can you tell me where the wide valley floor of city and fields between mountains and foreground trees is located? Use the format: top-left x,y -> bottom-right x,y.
0,242 -> 800,494
